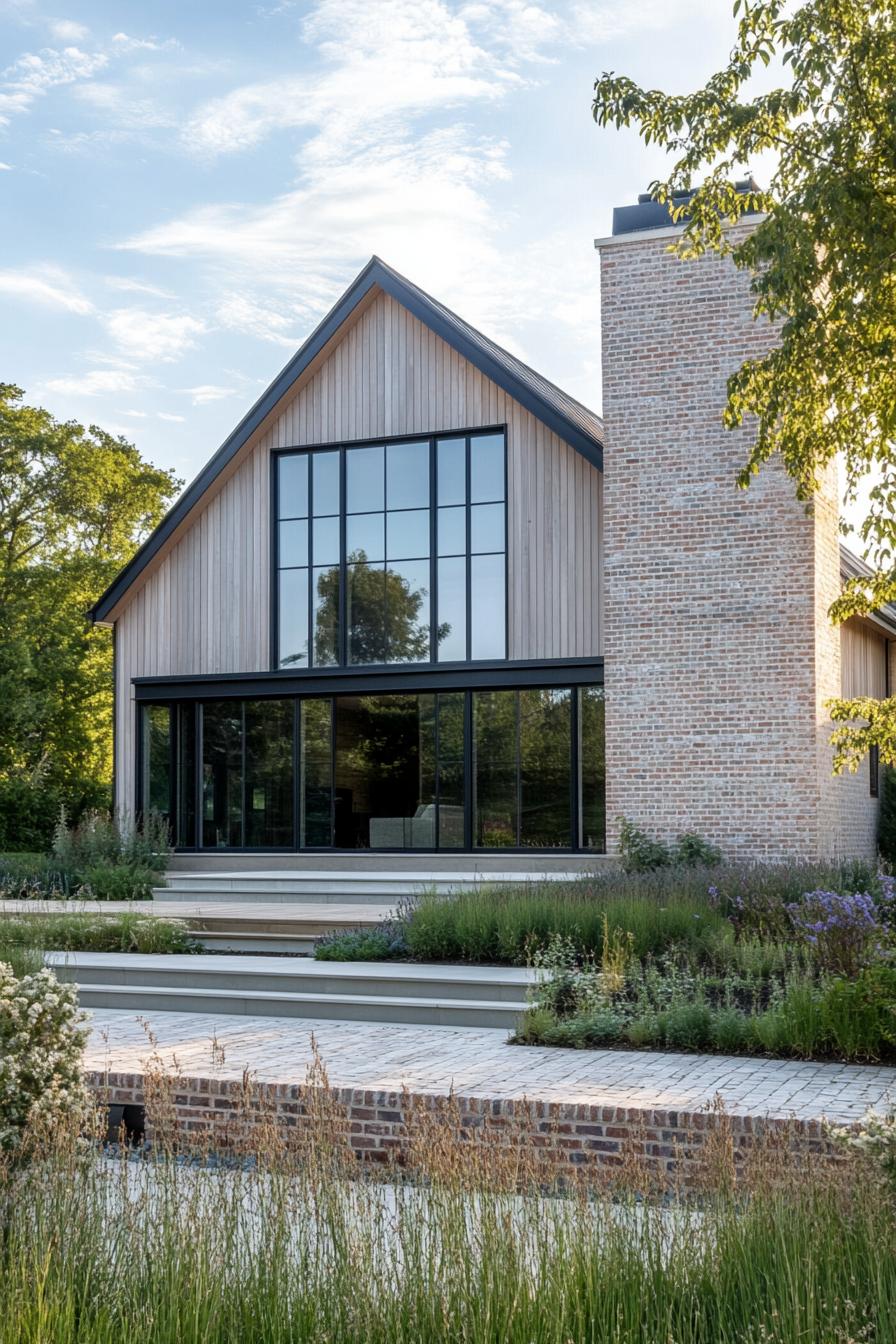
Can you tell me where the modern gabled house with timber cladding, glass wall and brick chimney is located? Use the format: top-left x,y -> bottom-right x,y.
93,197 -> 896,866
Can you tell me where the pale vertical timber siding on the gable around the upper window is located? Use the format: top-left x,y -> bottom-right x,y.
113,293 -> 602,809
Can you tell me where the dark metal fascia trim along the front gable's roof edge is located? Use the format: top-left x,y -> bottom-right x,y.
87,257 -> 603,624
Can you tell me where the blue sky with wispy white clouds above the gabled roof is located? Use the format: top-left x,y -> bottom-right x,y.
0,0 -> 733,478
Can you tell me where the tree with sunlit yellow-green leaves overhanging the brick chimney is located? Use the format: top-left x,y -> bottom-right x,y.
594,0 -> 896,770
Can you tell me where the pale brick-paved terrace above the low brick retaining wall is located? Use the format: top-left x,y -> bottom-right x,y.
86,1009 -> 896,1124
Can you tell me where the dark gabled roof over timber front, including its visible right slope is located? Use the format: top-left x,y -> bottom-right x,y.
89,257 -> 603,622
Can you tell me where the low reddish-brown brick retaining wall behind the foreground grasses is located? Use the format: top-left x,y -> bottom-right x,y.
89,1073 -> 838,1187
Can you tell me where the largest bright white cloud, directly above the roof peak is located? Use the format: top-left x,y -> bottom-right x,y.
120,0 -> 601,384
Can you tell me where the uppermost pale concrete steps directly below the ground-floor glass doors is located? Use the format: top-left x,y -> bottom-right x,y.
153,870 -> 582,907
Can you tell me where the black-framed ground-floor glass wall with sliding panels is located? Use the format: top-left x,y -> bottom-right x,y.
140,687 -> 606,851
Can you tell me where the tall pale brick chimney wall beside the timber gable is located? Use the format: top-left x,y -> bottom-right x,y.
600,226 -> 841,860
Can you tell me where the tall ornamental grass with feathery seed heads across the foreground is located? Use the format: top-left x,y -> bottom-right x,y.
0,1062 -> 896,1344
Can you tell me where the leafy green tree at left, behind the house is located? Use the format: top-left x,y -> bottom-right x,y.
0,384 -> 180,845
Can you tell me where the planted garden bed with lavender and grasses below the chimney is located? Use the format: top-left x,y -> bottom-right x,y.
316,863 -> 896,1062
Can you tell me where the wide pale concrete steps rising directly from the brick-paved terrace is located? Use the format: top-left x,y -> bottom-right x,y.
47,953 -> 535,1028
